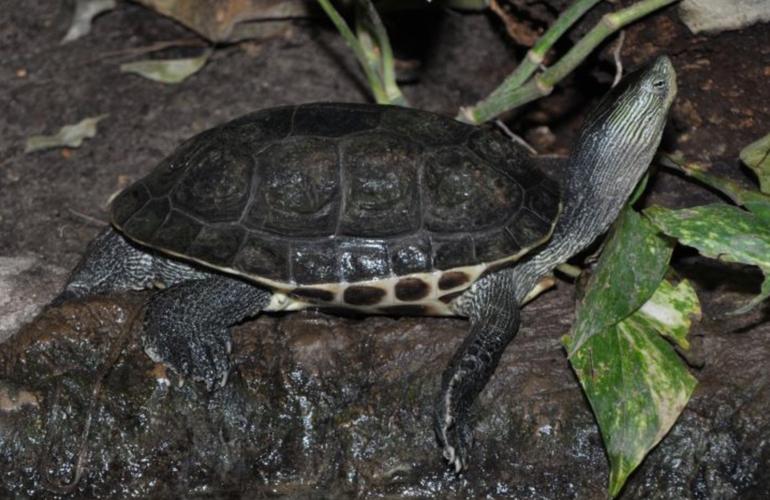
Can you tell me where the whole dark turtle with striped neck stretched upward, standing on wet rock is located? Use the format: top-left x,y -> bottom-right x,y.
57,56 -> 676,472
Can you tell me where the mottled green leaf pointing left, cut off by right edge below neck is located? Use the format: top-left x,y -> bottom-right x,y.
644,203 -> 770,314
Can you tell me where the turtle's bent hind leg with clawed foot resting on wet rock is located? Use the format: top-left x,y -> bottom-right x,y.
144,275 -> 272,390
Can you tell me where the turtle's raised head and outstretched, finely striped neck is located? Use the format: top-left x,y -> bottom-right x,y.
531,56 -> 676,276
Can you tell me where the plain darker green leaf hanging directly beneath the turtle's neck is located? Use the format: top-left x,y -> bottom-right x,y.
568,208 -> 673,356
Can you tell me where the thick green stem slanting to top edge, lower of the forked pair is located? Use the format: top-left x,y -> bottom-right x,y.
458,0 -> 679,123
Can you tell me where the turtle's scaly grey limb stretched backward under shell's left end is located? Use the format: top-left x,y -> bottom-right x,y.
52,227 -> 210,305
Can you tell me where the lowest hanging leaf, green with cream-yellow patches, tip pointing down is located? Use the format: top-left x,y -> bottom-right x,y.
565,281 -> 700,496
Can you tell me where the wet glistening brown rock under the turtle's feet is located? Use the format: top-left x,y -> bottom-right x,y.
0,285 -> 770,498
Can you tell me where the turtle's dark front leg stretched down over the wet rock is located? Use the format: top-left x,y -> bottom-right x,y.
433,272 -> 519,473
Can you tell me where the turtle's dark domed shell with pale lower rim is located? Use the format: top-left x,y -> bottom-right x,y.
112,103 -> 560,312
